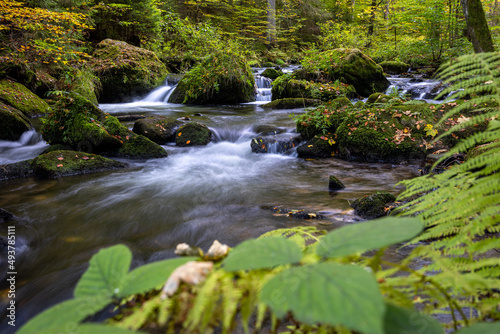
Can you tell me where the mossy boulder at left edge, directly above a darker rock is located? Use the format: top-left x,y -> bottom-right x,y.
0,79 -> 50,118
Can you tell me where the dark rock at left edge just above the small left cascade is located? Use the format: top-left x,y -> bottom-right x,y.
0,102 -> 31,140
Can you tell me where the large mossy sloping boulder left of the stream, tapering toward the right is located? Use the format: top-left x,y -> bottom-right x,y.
41,93 -> 167,159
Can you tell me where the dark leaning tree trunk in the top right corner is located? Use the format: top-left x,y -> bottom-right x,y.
460,0 -> 494,53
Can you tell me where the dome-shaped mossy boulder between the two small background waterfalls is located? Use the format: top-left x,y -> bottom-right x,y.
168,51 -> 255,104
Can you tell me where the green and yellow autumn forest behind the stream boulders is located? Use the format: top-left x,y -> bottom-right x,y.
0,0 -> 500,80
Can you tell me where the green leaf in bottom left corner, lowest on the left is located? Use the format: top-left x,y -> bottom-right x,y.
18,296 -> 110,334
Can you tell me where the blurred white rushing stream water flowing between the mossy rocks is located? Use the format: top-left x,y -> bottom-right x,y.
0,73 -> 434,333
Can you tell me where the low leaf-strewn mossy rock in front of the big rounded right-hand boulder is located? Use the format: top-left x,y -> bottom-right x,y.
271,74 -> 356,101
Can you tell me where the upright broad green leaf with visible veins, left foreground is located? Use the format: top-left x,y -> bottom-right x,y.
75,245 -> 132,298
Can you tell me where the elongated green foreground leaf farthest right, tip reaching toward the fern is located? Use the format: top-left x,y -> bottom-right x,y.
317,217 -> 424,258
